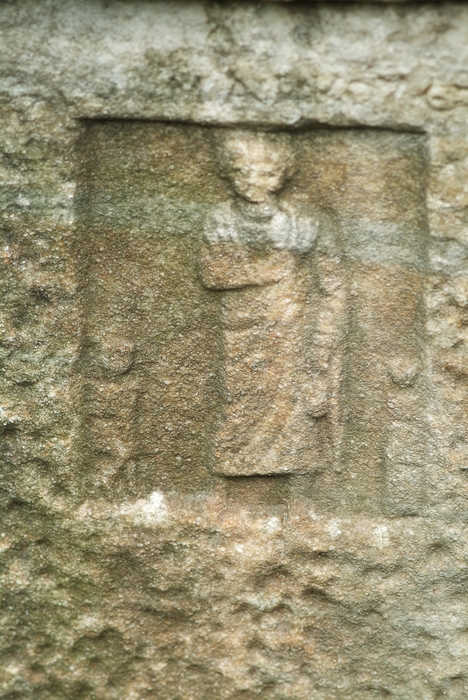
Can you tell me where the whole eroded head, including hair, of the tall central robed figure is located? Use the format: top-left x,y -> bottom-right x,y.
218,129 -> 293,203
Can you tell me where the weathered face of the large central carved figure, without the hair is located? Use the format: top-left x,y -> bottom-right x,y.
226,138 -> 286,203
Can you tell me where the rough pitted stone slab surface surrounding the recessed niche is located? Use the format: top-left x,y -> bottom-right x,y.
0,0 -> 468,700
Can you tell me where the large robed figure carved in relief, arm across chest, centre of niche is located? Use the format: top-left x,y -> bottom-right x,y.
201,130 -> 327,475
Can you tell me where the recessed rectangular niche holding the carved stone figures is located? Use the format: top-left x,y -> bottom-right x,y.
78,121 -> 427,512
